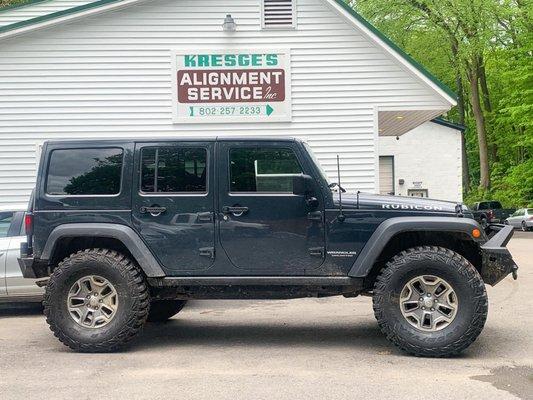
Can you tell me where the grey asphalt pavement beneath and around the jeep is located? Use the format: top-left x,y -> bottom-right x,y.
0,232 -> 533,400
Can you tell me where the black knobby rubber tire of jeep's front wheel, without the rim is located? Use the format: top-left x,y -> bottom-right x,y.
373,246 -> 488,357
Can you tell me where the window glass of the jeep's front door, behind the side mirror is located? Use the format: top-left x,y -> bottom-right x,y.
230,147 -> 302,193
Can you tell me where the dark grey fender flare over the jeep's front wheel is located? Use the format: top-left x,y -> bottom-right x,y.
348,217 -> 486,278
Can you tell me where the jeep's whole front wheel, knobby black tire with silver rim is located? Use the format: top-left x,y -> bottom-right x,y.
373,246 -> 488,357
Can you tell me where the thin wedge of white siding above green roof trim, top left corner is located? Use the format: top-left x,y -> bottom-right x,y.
0,0 -> 95,27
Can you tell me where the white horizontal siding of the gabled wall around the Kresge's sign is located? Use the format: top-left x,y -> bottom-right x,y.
0,0 -> 449,204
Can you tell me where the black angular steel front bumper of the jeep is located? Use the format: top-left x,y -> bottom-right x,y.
481,225 -> 518,286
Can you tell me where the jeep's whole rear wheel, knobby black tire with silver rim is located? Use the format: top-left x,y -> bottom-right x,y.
43,249 -> 150,352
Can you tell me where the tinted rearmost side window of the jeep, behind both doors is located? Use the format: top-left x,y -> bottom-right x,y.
46,148 -> 123,195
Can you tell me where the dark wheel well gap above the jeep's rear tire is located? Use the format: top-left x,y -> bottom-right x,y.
50,236 -> 137,269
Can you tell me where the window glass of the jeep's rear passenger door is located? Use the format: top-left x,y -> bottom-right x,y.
141,147 -> 207,193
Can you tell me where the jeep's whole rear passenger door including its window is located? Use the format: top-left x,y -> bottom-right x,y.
132,142 -> 215,276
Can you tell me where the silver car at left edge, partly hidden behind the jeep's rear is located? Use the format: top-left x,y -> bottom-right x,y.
0,208 -> 44,303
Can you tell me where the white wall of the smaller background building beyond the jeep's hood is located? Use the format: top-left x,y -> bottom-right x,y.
379,122 -> 463,201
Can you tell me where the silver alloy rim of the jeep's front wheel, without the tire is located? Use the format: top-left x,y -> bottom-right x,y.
400,275 -> 459,332
